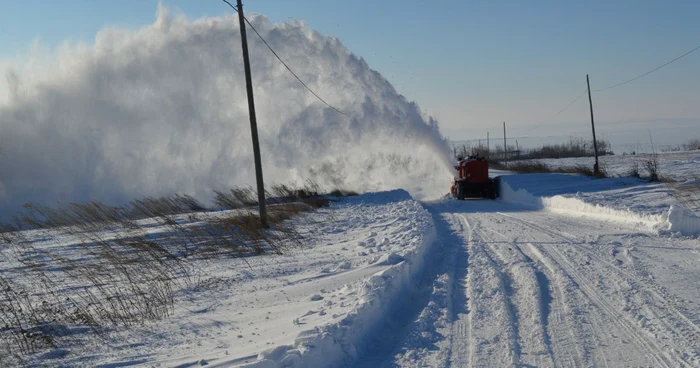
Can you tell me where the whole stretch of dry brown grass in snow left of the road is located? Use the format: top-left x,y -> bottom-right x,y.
0,183 -> 344,359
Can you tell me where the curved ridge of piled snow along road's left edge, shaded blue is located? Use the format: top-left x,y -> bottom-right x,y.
240,190 -> 437,368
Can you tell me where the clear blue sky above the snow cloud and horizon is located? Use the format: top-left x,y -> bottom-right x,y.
0,0 -> 700,145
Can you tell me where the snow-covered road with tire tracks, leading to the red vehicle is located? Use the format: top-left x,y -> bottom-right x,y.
366,201 -> 700,367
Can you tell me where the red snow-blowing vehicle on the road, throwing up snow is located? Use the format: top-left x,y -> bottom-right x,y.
450,155 -> 500,200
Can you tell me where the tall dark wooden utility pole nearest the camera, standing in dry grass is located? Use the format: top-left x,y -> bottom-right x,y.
238,0 -> 269,228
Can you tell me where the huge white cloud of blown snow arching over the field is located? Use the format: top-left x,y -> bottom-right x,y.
0,6 -> 450,215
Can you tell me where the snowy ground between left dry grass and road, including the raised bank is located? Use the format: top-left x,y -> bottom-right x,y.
2,190 -> 434,366
